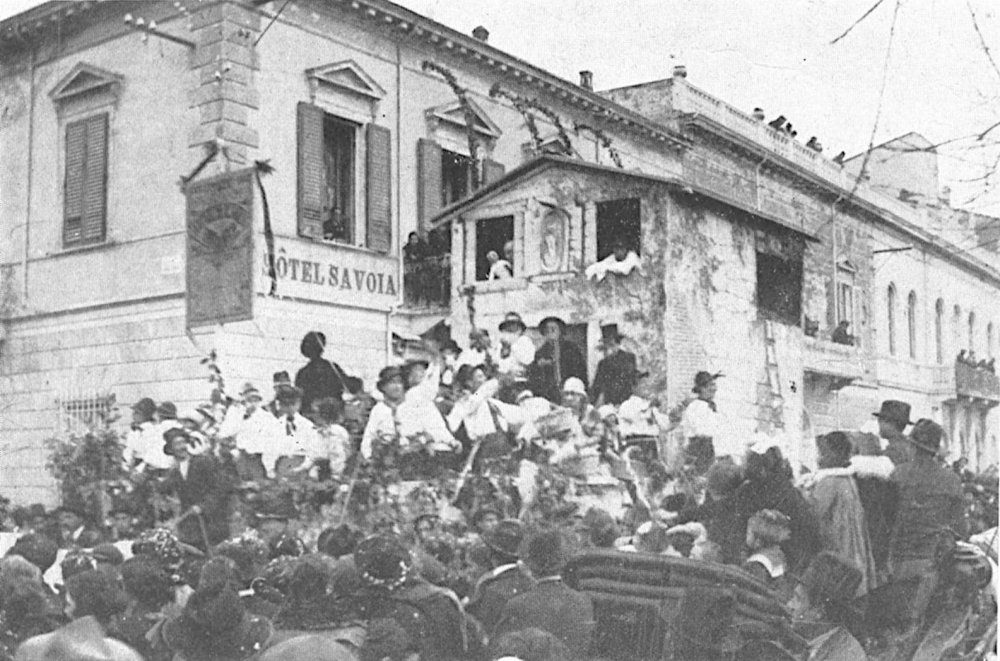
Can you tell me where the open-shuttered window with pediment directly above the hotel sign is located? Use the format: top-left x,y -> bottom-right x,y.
298,103 -> 392,252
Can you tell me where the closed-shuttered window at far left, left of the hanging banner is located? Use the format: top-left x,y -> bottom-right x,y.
63,113 -> 108,246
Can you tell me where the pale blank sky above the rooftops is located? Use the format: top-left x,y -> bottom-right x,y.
0,0 -> 1000,215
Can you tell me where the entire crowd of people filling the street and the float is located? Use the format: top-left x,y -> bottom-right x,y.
0,313 -> 997,661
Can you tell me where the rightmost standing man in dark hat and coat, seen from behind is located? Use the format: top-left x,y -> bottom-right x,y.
890,420 -> 965,624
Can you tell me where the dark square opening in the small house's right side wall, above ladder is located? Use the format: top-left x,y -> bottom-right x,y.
756,232 -> 805,326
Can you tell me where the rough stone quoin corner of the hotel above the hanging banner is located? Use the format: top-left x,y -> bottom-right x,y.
188,2 -> 261,164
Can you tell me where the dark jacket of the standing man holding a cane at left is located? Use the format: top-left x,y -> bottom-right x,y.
163,455 -> 229,548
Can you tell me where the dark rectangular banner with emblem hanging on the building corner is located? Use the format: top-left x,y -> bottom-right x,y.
185,168 -> 254,328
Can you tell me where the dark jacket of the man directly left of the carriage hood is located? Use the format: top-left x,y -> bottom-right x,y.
493,580 -> 594,659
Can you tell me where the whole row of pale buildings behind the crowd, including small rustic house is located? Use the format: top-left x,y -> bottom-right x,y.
0,0 -> 1000,501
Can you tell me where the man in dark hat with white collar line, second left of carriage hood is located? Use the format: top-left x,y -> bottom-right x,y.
466,519 -> 535,631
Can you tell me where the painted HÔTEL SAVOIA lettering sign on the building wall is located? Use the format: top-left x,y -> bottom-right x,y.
260,237 -> 401,310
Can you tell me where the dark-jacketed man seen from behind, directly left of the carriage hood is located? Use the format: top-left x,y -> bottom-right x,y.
492,530 -> 594,659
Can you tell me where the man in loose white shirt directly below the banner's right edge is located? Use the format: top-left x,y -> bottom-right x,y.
218,382 -> 284,480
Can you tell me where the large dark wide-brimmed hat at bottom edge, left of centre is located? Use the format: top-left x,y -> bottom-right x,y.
162,583 -> 274,658
